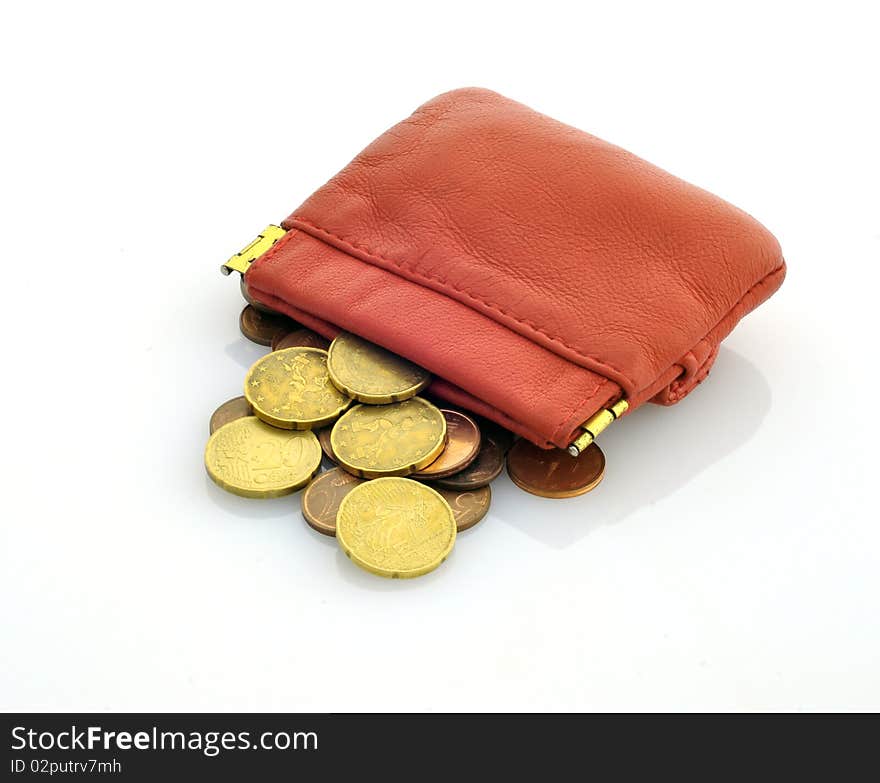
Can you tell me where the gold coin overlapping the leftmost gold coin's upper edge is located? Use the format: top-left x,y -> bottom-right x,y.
244,348 -> 351,430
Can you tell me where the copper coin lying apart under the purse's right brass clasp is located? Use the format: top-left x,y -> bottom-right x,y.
507,438 -> 605,498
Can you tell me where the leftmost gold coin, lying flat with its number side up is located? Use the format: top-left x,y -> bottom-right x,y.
205,416 -> 321,498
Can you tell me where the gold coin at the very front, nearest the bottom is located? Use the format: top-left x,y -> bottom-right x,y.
336,478 -> 455,579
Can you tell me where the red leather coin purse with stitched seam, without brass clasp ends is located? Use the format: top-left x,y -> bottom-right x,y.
247,88 -> 785,446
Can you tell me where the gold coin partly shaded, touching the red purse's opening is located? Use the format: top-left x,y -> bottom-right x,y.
327,332 -> 431,405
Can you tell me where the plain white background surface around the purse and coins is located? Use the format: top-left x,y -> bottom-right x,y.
0,0 -> 880,711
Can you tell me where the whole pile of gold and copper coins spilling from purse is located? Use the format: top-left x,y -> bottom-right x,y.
205,298 -> 605,578
